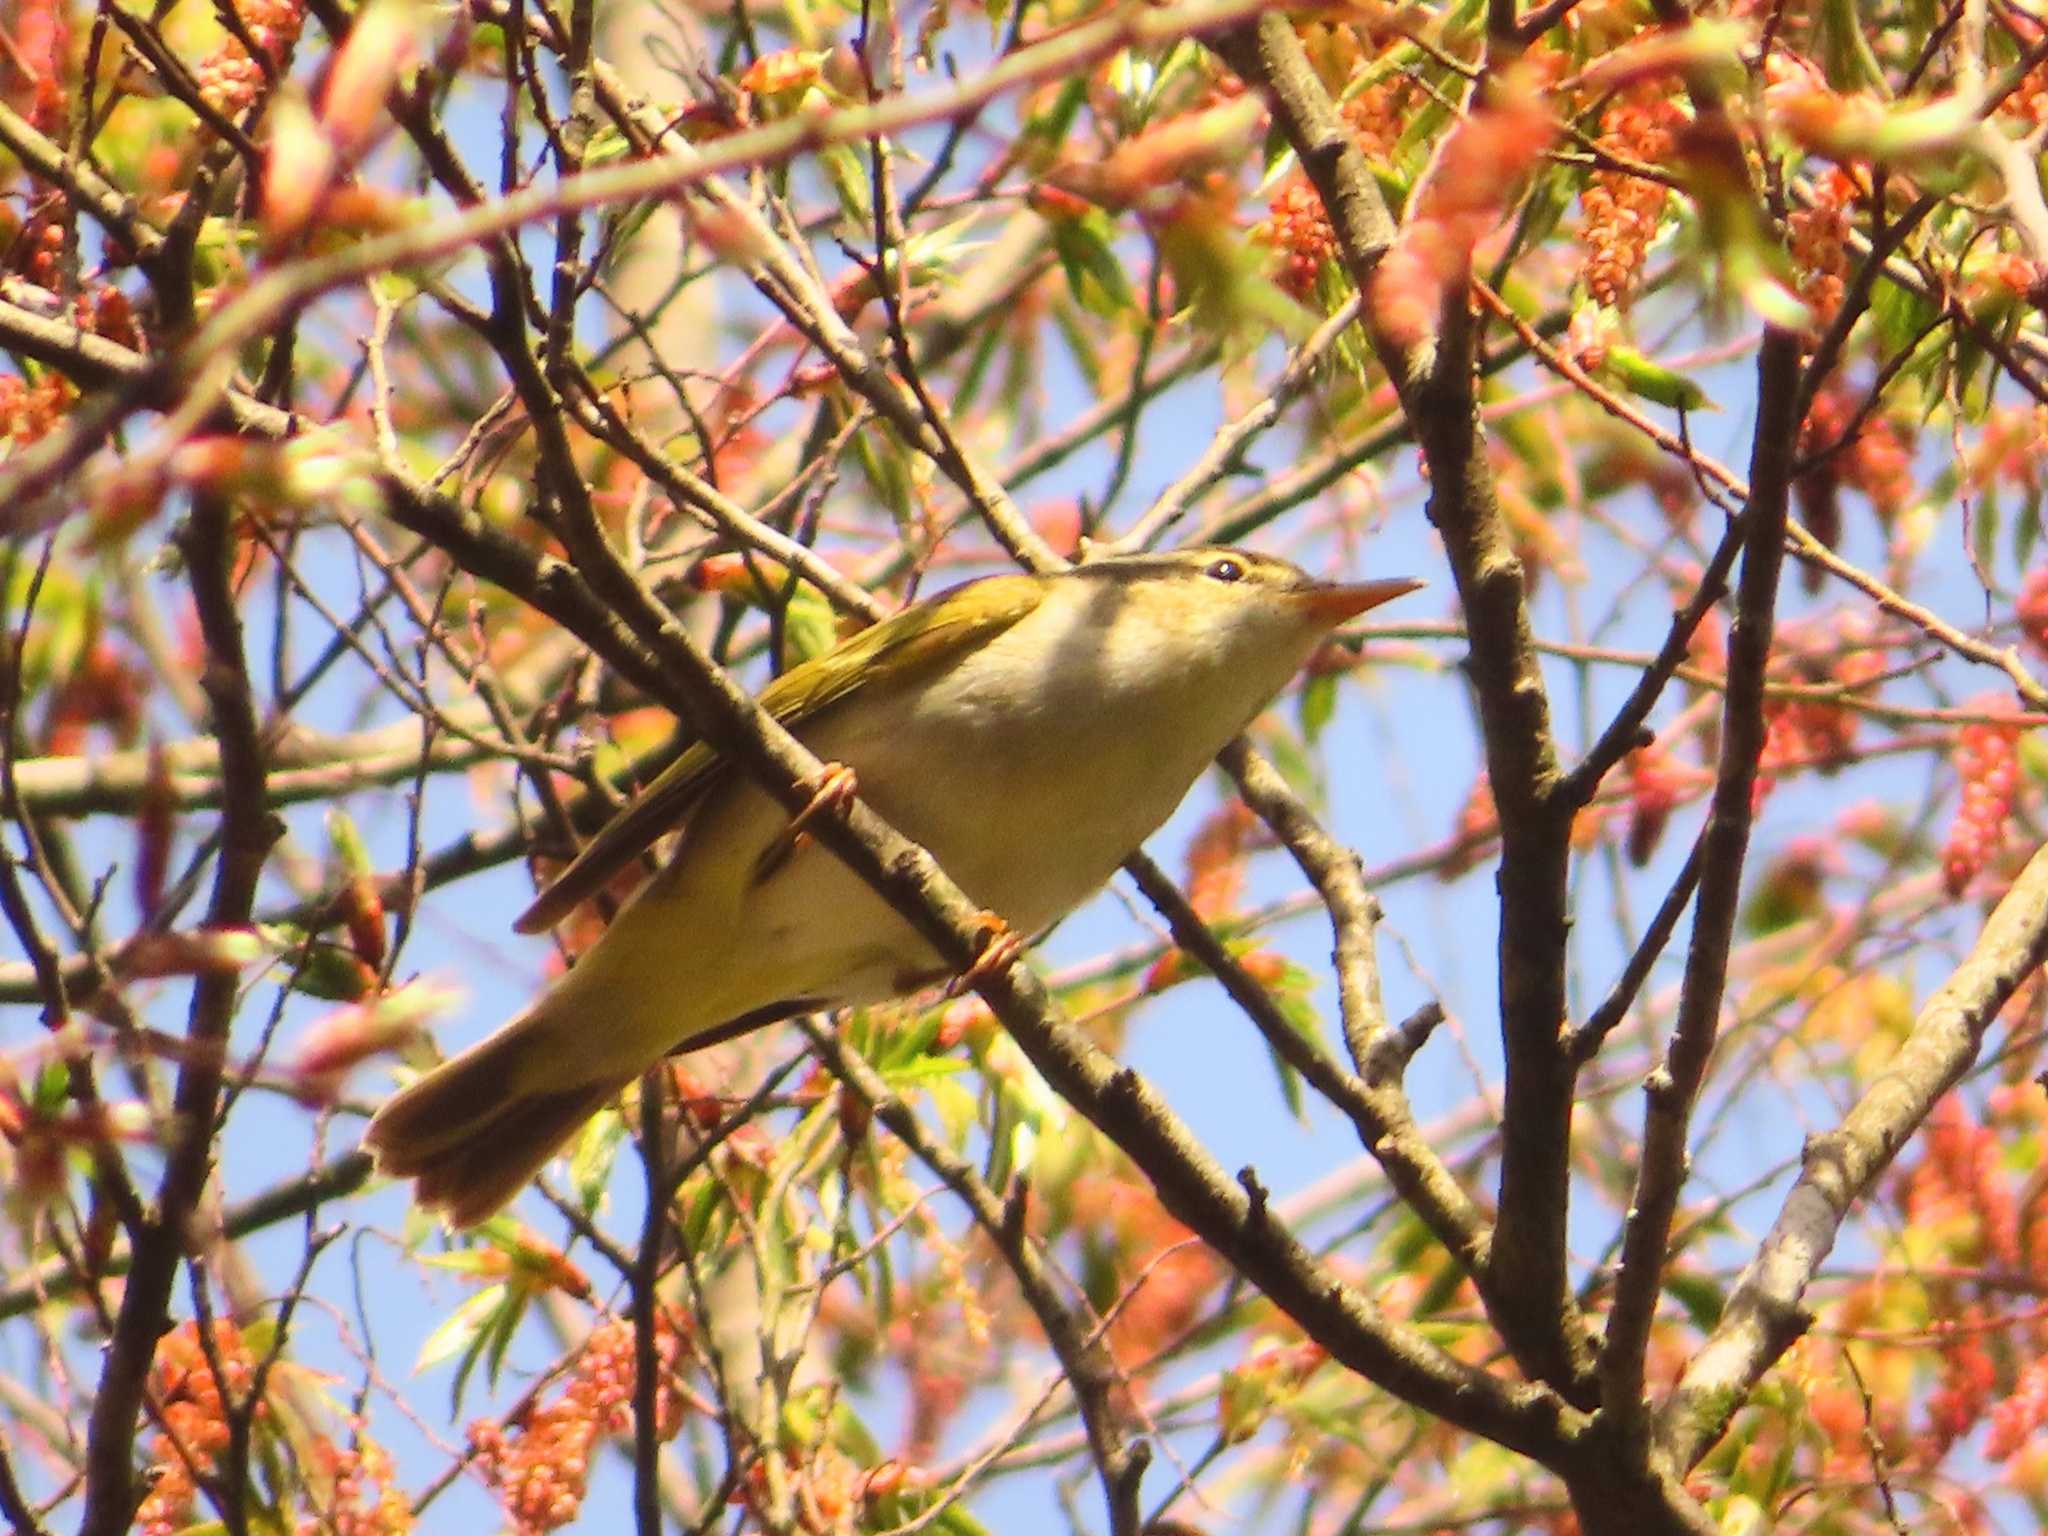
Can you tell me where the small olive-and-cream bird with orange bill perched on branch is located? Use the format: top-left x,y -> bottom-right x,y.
365,547 -> 1421,1227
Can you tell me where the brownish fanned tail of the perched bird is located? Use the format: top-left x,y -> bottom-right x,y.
362,1010 -> 633,1227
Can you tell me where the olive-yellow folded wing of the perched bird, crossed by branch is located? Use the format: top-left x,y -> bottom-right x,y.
512,575 -> 1042,934
